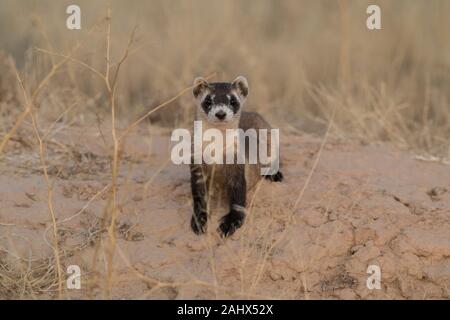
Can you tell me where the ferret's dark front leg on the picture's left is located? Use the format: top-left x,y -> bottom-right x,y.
191,164 -> 208,234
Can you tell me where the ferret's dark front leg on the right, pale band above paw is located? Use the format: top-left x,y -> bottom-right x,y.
218,165 -> 247,237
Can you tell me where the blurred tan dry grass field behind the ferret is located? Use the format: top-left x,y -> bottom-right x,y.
0,0 -> 450,157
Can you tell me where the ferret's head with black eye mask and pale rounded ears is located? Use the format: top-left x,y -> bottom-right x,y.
192,76 -> 248,124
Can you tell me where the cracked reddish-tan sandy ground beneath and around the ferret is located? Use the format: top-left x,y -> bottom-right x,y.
0,123 -> 450,299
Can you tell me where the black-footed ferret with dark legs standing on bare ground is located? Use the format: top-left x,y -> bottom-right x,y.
190,76 -> 283,237
